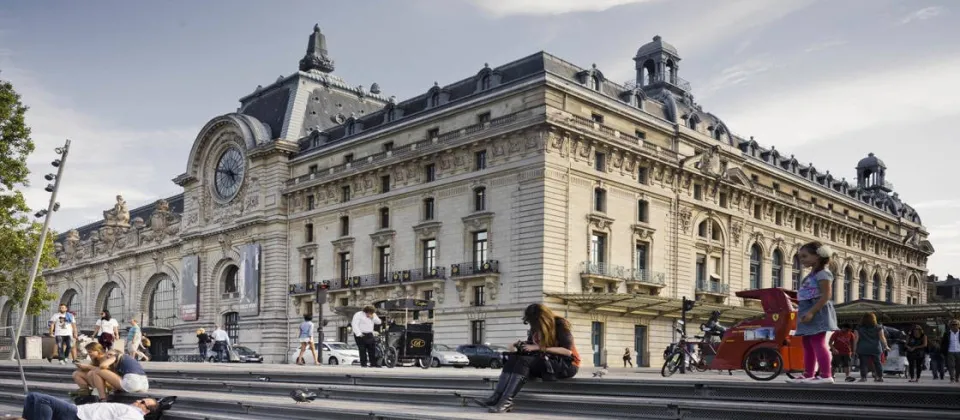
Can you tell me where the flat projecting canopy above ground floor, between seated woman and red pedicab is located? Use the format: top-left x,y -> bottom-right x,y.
545,293 -> 763,322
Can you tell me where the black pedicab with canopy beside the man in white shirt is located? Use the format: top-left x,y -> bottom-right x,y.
373,299 -> 435,369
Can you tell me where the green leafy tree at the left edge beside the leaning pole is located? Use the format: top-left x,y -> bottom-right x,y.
0,76 -> 58,315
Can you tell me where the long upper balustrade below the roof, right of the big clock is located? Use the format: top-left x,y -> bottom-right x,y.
286,112 -> 520,186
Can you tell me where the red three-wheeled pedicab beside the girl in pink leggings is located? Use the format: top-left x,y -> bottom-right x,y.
661,288 -> 803,381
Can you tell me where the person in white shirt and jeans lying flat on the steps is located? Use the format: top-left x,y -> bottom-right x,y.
23,392 -> 159,420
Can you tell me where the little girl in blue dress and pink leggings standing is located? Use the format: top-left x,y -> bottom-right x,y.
790,242 -> 839,383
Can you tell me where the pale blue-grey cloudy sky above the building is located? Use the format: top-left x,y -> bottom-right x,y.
0,0 -> 960,278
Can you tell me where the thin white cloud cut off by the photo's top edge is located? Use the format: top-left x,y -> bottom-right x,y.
470,0 -> 656,17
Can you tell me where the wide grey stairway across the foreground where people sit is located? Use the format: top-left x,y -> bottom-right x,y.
0,362 -> 960,420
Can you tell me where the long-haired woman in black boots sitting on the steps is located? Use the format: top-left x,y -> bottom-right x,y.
474,303 -> 580,413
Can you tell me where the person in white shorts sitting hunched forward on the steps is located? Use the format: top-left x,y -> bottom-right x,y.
73,343 -> 150,401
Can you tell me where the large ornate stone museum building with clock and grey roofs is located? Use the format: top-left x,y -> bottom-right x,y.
0,27 -> 933,366
